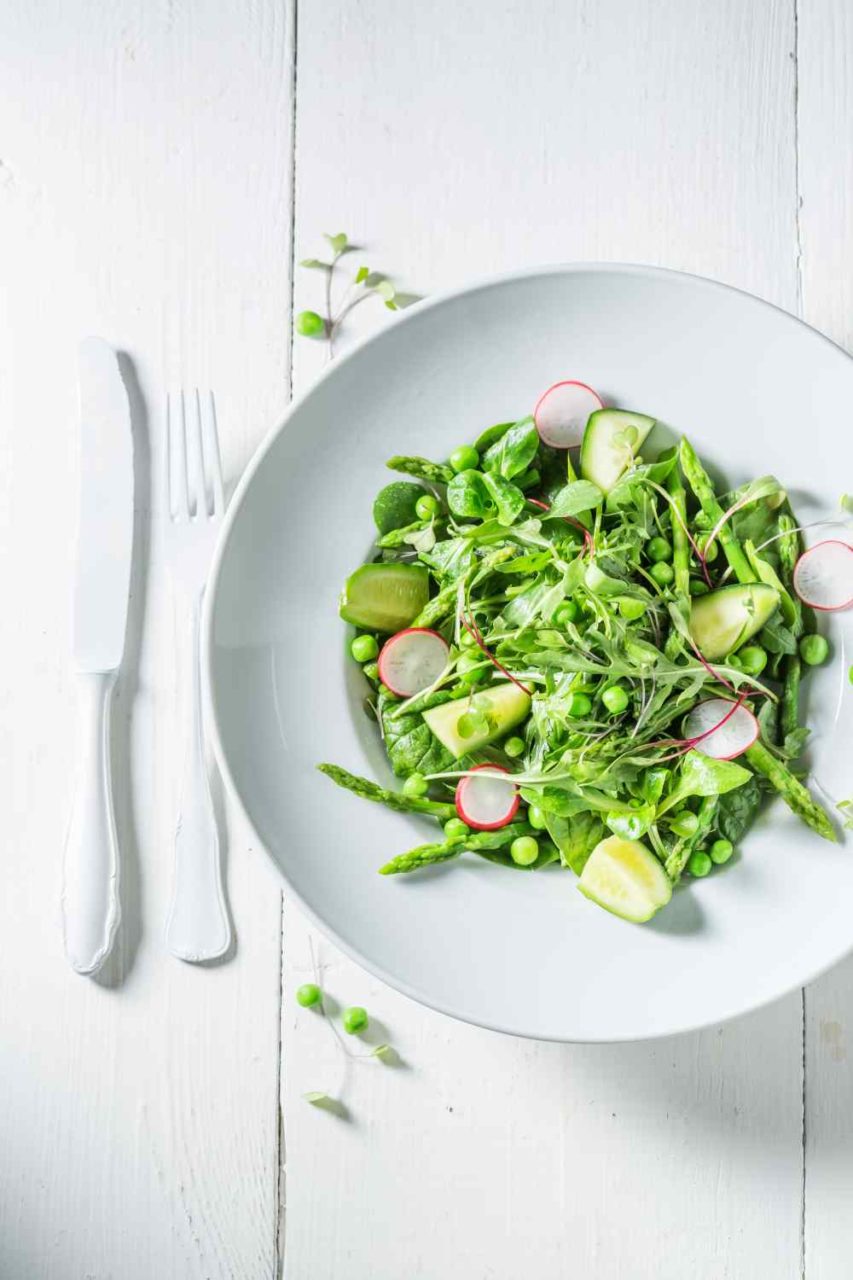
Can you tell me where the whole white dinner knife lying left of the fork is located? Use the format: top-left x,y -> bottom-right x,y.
63,338 -> 133,974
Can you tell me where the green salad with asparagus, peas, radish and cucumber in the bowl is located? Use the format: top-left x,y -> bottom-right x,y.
320,383 -> 835,923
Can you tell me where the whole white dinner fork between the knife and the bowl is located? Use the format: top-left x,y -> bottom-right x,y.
165,388 -> 231,960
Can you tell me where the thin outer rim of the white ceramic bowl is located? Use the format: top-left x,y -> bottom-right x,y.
201,261 -> 853,1044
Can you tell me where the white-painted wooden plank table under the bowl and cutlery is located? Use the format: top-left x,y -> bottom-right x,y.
0,0 -> 853,1280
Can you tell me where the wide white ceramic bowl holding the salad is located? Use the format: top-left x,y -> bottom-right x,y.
205,265 -> 853,1041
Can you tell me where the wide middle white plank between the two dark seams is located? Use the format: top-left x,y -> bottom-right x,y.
282,0 -> 803,1280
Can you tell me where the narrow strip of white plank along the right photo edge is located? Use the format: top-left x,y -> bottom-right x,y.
798,0 -> 853,1280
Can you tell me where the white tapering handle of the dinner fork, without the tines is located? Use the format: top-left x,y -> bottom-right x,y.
167,596 -> 231,961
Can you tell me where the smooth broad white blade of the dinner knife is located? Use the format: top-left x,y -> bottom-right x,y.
74,338 -> 133,671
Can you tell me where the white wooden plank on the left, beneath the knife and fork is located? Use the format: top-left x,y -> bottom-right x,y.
0,0 -> 292,1280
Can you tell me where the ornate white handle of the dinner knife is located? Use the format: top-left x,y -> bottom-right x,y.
63,671 -> 120,974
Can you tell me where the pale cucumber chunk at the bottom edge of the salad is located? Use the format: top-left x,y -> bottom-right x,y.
578,836 -> 672,924
